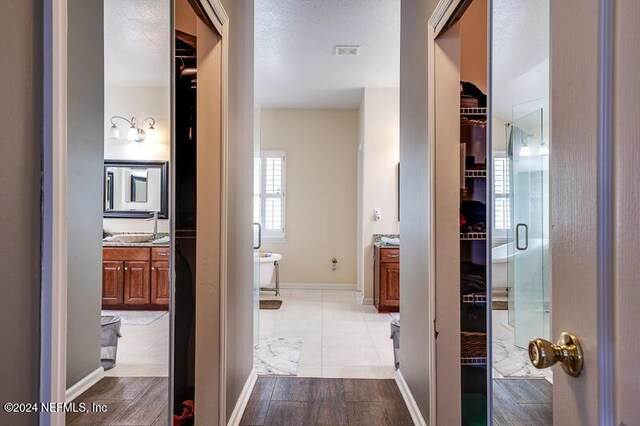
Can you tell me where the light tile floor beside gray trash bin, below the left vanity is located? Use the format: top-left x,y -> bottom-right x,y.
105,311 -> 169,377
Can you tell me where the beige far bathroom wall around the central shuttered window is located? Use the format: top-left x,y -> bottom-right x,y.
261,109 -> 358,286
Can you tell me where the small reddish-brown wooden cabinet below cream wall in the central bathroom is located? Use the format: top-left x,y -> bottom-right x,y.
373,245 -> 400,312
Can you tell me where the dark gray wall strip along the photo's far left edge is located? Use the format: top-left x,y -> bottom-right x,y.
0,0 -> 42,425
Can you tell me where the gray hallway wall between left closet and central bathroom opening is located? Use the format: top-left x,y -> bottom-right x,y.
222,0 -> 254,419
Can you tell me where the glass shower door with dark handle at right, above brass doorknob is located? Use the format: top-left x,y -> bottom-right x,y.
508,109 -> 550,349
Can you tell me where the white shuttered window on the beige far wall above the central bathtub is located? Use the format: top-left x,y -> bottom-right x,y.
254,151 -> 286,243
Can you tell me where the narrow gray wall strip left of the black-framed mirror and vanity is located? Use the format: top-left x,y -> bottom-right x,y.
67,0 -> 104,388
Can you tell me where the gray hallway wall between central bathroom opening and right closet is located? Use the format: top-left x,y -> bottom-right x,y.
400,0 -> 437,421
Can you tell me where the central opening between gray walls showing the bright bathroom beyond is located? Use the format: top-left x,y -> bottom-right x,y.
253,0 -> 400,379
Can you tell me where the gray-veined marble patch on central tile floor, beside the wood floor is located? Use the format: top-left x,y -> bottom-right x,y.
253,337 -> 302,376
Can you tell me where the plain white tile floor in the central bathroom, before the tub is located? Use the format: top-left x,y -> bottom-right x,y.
260,289 -> 394,379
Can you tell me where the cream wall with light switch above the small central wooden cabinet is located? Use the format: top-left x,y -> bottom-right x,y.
358,88 -> 400,303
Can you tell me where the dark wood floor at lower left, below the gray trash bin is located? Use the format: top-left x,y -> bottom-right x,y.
67,377 -> 169,426
